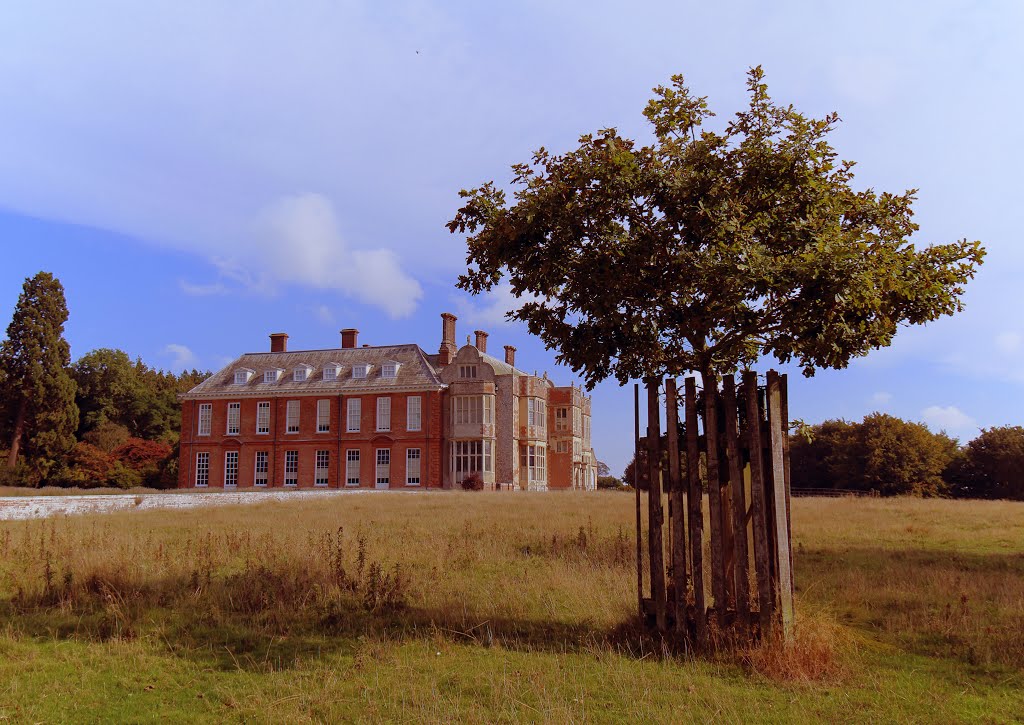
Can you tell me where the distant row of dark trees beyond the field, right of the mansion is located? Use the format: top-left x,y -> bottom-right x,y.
614,413 -> 1024,501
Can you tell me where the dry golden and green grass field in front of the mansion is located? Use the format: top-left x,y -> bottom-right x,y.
0,493 -> 1024,722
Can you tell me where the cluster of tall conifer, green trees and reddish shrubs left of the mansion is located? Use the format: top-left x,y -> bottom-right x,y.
0,271 -> 210,488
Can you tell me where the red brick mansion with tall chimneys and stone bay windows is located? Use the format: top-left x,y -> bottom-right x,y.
178,312 -> 597,491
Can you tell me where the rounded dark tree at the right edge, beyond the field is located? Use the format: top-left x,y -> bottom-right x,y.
947,426 -> 1024,501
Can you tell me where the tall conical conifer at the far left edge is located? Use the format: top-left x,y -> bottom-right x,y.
0,272 -> 78,481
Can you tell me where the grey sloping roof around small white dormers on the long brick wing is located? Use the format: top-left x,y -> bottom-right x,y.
181,345 -> 444,400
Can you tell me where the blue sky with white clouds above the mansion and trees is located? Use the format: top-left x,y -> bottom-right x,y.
0,0 -> 1024,473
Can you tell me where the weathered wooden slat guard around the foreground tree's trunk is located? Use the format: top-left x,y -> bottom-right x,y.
635,371 -> 794,648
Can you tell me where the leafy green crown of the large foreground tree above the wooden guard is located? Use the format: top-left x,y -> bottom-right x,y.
447,68 -> 984,390
